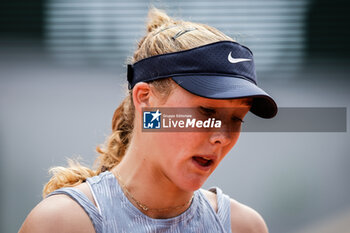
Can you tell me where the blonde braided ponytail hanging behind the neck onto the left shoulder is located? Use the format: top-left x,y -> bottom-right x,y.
43,91 -> 134,198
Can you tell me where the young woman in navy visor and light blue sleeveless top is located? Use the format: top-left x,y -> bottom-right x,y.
20,9 -> 277,233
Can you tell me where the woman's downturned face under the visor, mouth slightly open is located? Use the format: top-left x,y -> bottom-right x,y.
138,86 -> 252,191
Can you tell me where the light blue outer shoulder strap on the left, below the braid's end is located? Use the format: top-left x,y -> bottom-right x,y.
46,187 -> 103,233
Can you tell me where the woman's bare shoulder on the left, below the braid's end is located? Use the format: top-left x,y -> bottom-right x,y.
19,184 -> 95,233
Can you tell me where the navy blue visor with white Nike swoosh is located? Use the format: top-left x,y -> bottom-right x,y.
127,41 -> 277,118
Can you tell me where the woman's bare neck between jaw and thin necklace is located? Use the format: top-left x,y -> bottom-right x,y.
111,138 -> 193,218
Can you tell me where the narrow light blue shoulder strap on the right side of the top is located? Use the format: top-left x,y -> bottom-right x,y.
209,187 -> 231,232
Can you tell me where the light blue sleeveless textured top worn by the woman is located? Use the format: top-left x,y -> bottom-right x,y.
47,171 -> 231,233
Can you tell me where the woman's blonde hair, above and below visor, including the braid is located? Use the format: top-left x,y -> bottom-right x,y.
43,8 -> 234,197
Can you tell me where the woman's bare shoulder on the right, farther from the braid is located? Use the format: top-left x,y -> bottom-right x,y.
230,199 -> 268,233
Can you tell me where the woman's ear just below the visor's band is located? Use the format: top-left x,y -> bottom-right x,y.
132,82 -> 154,113
